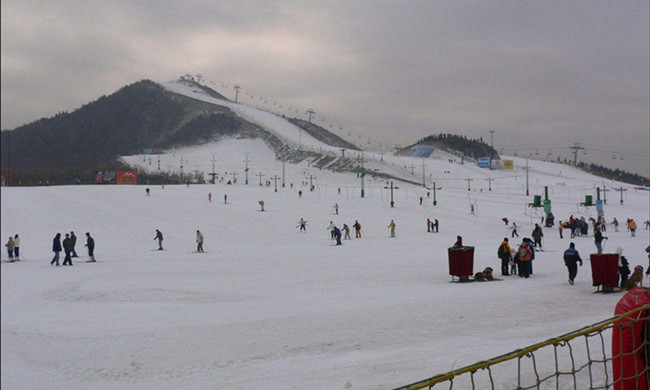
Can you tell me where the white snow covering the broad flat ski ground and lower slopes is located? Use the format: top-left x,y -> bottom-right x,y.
1,81 -> 650,389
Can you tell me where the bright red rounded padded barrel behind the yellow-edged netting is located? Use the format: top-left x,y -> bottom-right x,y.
612,287 -> 650,390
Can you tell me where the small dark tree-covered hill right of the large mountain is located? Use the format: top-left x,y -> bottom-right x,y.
399,133 -> 501,160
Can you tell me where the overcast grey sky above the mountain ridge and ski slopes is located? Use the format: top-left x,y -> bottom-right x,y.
1,0 -> 650,176
